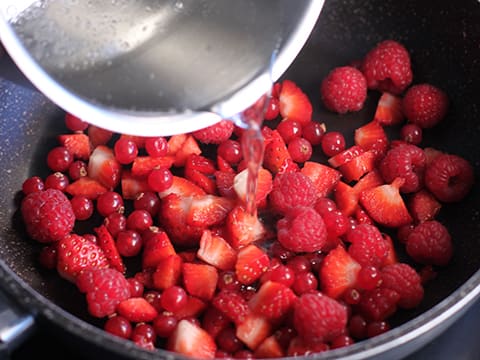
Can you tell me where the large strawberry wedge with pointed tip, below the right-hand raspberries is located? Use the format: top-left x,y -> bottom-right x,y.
360,178 -> 412,227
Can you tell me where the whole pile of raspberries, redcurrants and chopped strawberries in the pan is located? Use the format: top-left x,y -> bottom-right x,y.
21,40 -> 474,358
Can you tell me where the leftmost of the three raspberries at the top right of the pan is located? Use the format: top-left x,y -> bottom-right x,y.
320,66 -> 367,114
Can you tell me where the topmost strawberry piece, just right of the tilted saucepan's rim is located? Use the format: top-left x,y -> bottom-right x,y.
278,80 -> 312,125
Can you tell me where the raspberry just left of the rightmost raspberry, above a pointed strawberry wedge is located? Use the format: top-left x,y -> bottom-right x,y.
379,144 -> 426,193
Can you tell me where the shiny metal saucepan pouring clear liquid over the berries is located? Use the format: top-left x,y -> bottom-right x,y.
0,0 -> 323,135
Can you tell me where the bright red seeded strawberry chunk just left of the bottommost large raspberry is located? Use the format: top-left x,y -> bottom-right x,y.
248,281 -> 297,320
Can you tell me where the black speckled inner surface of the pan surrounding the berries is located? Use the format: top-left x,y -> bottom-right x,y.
0,0 -> 480,359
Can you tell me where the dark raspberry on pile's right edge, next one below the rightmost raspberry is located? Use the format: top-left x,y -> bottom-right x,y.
406,220 -> 453,266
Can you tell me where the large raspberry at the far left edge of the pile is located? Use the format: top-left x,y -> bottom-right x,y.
21,189 -> 75,243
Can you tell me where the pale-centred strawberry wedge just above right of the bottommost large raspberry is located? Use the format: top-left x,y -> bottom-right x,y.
319,246 -> 361,299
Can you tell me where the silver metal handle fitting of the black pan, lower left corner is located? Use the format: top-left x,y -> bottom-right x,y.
0,291 -> 35,359
